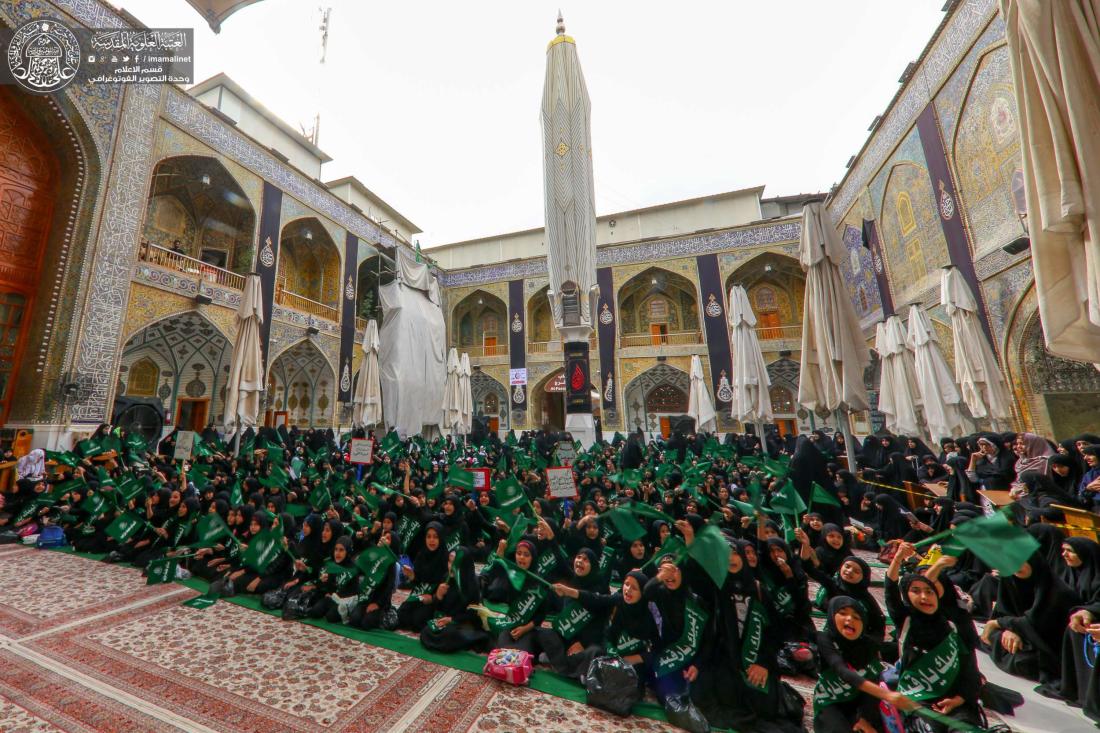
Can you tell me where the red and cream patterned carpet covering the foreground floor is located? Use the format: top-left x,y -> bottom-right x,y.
0,546 -> 674,733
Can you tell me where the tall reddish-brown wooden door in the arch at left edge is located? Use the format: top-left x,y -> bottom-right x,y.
0,87 -> 58,425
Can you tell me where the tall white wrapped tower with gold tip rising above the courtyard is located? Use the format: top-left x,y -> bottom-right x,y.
542,14 -> 600,445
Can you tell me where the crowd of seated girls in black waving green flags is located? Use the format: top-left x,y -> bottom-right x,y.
0,422 -> 1100,733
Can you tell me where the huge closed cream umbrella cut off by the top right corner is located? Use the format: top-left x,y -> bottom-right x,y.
1001,0 -> 1100,363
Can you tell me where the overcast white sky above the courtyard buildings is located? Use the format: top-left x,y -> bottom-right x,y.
114,0 -> 944,247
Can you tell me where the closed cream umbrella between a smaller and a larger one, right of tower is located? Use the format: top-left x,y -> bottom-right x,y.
729,285 -> 774,440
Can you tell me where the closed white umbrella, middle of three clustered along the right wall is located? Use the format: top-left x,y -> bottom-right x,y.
905,306 -> 965,441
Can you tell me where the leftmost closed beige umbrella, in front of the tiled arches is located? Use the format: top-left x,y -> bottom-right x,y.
224,273 -> 264,452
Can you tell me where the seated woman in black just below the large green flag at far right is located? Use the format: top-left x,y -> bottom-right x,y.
981,550 -> 1075,682
